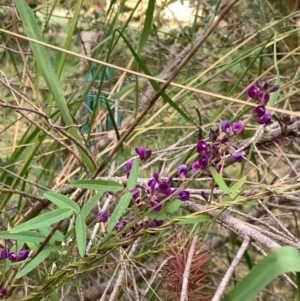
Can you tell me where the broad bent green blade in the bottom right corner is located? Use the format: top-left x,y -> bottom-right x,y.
223,246 -> 300,301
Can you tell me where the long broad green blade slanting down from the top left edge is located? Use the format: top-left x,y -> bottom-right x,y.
14,0 -> 95,171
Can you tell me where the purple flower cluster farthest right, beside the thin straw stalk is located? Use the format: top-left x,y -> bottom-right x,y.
248,81 -> 280,124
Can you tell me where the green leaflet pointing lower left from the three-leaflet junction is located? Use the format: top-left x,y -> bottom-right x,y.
9,208 -> 73,233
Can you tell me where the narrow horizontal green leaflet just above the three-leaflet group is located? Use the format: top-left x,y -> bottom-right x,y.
71,180 -> 124,191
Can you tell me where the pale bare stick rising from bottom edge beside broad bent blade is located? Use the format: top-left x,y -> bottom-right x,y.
211,237 -> 250,301
